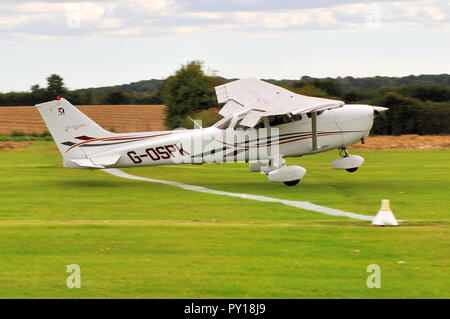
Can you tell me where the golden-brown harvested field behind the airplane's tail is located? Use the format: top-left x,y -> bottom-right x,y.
0,105 -> 165,134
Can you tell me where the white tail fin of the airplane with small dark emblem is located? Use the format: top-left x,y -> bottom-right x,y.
36,98 -> 115,162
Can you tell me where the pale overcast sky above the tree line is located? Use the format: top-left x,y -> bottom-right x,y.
0,0 -> 450,92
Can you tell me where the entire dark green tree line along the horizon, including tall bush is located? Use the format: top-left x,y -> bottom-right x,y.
0,65 -> 450,135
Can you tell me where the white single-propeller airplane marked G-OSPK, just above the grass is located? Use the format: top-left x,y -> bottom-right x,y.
36,79 -> 387,186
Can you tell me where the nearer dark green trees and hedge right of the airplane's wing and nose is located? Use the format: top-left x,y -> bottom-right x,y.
268,78 -> 450,135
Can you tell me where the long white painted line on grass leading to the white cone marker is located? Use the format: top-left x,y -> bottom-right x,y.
103,168 -> 374,221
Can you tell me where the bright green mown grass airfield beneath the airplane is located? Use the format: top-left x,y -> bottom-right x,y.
0,142 -> 450,298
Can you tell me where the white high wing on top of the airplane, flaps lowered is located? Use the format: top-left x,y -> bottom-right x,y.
215,78 -> 344,127
